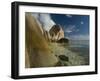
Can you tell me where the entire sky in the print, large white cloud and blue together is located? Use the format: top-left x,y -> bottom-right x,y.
32,13 -> 89,40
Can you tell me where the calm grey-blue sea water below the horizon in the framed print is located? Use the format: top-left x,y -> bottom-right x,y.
68,40 -> 89,65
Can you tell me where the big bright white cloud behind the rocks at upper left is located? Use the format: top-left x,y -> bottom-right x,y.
32,13 -> 55,31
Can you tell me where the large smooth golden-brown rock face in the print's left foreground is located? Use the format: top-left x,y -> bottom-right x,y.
25,13 -> 58,68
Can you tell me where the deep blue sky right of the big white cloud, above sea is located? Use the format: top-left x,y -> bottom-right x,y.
50,14 -> 89,40
